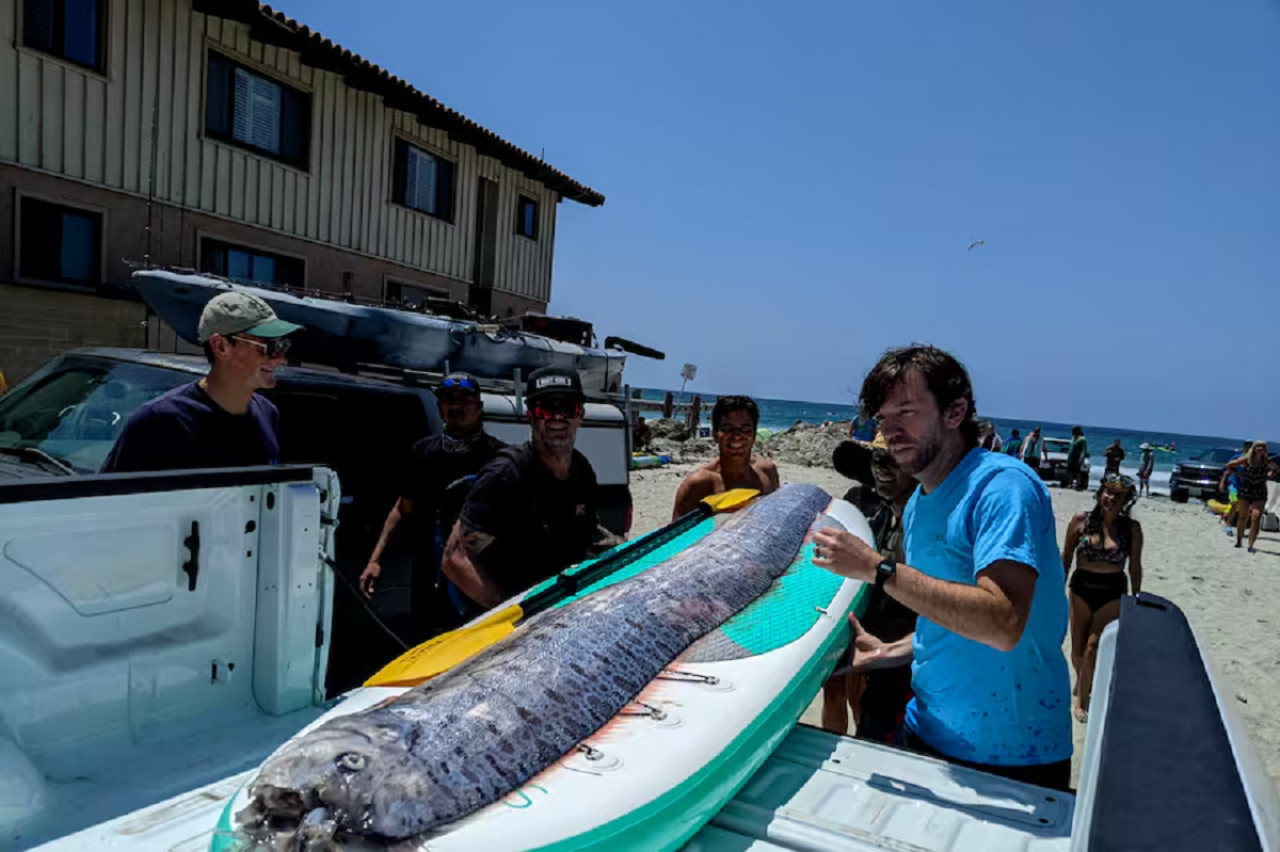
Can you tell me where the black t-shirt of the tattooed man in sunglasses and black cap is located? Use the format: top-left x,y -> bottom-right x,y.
462,443 -> 599,595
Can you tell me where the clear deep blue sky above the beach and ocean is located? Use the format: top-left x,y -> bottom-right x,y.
280,0 -> 1280,438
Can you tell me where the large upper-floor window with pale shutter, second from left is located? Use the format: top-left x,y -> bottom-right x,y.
205,51 -> 311,169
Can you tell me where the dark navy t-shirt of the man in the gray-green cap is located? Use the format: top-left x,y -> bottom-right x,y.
101,381 -> 280,473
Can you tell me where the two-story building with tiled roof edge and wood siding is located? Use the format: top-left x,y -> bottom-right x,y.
0,0 -> 604,381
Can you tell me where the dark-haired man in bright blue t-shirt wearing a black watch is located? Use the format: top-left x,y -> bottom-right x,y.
814,347 -> 1071,789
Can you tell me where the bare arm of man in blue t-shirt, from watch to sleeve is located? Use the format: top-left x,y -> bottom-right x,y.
884,559 -> 1038,651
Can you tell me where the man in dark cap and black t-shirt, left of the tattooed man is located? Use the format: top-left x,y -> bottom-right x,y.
360,372 -> 506,633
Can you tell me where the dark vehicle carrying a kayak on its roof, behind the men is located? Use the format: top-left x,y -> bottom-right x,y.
0,349 -> 631,695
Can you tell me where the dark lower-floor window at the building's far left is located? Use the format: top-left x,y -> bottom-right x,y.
18,197 -> 102,284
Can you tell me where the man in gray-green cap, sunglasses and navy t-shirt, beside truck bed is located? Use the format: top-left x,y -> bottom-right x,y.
101,293 -> 302,473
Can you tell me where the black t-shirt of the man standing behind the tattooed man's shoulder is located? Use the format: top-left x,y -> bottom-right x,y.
401,432 -> 507,539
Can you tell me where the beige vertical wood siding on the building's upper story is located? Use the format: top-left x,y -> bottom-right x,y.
0,0 -> 557,302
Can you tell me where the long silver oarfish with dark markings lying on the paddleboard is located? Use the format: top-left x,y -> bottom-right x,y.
237,485 -> 831,848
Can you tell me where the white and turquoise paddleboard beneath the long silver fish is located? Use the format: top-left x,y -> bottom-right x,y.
211,500 -> 873,852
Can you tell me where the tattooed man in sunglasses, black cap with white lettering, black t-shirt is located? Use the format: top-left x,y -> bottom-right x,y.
442,367 -> 622,609
